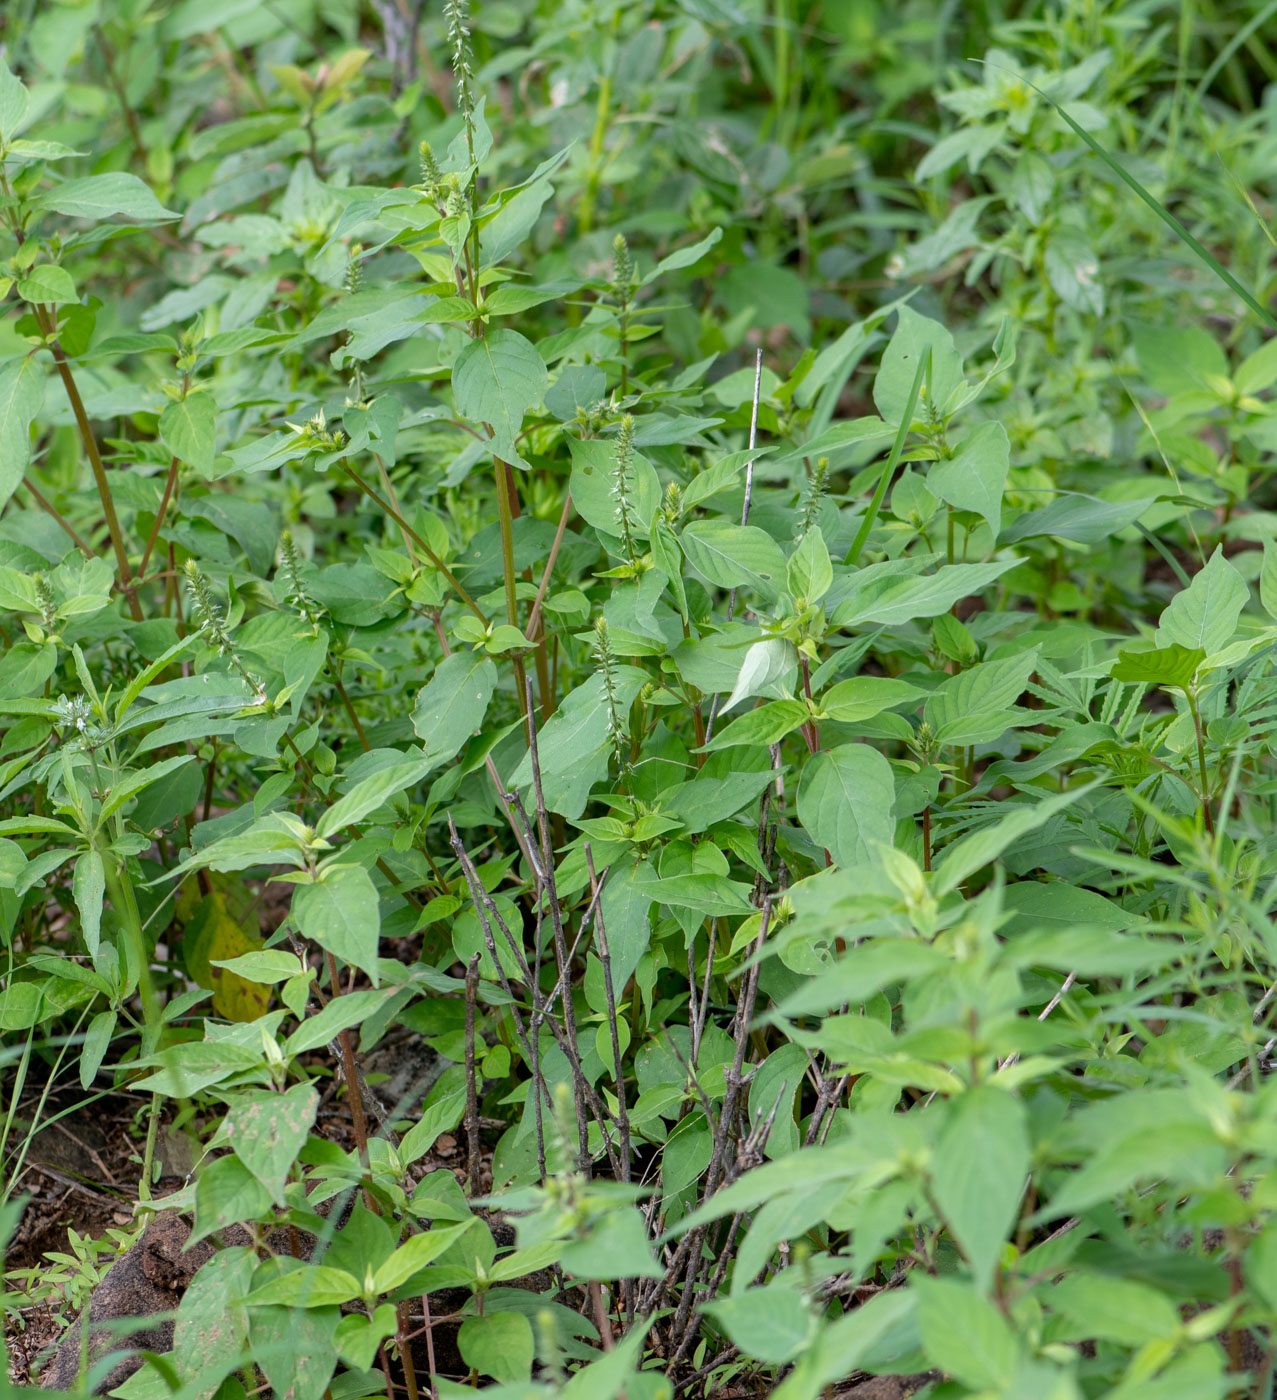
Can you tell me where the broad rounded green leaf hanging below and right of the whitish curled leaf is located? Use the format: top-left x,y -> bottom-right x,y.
798,743 -> 896,867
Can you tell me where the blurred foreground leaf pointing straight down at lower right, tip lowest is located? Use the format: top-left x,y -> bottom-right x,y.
931,1084 -> 1029,1294
